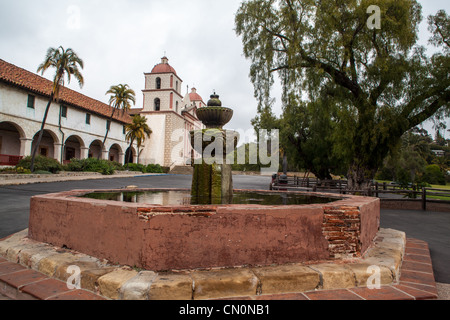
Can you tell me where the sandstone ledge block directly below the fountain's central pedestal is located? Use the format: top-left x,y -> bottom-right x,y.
191,269 -> 259,300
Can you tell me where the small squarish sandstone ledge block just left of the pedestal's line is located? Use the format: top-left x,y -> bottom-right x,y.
148,274 -> 193,301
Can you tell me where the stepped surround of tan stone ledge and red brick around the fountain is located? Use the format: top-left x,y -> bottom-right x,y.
0,229 -> 437,300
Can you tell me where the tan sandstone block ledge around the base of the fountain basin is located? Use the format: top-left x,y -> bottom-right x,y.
0,229 -> 422,300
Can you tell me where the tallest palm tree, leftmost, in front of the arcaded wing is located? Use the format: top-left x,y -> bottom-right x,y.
30,46 -> 84,172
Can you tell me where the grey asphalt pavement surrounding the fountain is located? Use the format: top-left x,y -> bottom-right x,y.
0,175 -> 450,284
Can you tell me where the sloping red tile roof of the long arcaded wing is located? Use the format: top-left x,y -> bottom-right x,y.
0,59 -> 131,123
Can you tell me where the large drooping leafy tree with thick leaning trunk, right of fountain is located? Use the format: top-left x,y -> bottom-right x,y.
236,0 -> 450,190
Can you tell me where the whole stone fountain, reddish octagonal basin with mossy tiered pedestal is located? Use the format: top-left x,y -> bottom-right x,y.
29,94 -> 380,271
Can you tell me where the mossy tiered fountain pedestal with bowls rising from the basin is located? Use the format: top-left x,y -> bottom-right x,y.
190,94 -> 239,204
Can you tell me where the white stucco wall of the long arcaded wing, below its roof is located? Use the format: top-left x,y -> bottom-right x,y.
0,83 -> 133,164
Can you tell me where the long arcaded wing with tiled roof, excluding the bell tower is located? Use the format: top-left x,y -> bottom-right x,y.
0,60 -> 137,165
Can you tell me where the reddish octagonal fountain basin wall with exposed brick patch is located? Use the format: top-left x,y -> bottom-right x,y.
29,190 -> 380,271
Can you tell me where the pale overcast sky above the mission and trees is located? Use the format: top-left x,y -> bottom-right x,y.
0,0 -> 450,137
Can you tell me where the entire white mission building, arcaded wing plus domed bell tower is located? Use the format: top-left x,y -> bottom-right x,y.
0,57 -> 206,168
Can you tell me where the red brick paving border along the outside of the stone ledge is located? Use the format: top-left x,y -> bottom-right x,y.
0,239 -> 438,300
